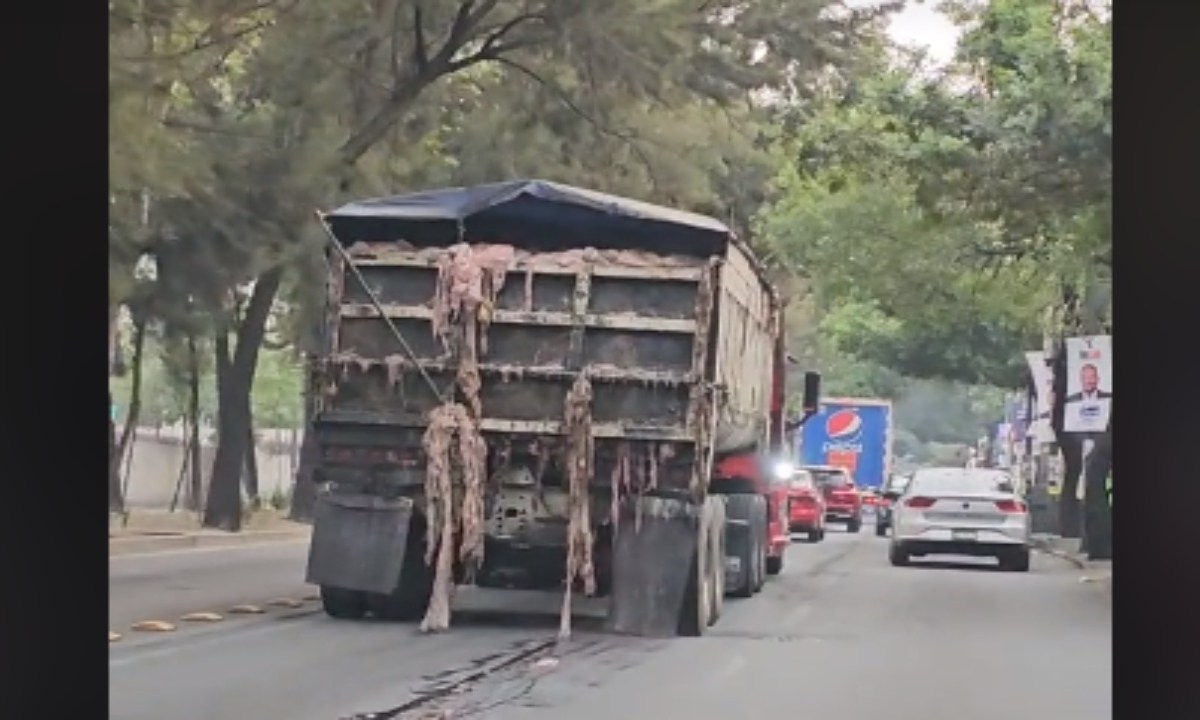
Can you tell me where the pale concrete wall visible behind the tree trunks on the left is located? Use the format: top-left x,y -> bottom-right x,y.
116,427 -> 304,509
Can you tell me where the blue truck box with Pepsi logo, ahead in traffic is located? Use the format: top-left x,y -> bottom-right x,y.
796,397 -> 892,490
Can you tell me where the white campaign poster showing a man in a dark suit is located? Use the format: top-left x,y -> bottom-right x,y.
1063,335 -> 1112,432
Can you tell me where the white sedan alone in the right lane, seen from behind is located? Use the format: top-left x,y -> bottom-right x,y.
888,468 -> 1030,572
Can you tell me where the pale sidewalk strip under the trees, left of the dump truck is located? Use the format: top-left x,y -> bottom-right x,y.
108,510 -> 311,557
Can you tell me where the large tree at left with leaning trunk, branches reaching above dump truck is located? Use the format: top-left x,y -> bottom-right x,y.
110,0 -> 902,529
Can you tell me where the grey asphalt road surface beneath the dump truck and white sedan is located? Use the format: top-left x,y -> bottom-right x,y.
109,529 -> 1112,720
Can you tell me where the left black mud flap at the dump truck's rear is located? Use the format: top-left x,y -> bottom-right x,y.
306,493 -> 414,595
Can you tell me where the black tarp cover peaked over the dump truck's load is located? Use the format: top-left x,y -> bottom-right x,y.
324,180 -> 732,256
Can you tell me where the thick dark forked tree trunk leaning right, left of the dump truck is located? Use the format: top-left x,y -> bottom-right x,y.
204,266 -> 283,532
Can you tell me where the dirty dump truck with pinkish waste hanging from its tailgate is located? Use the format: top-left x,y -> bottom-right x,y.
299,180 -> 820,636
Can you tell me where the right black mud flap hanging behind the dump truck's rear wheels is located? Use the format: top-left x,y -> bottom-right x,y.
608,497 -> 701,637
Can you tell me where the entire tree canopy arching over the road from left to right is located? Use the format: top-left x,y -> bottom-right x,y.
109,0 -> 1111,523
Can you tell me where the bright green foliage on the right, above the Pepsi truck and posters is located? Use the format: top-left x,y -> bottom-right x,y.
757,0 -> 1111,388
